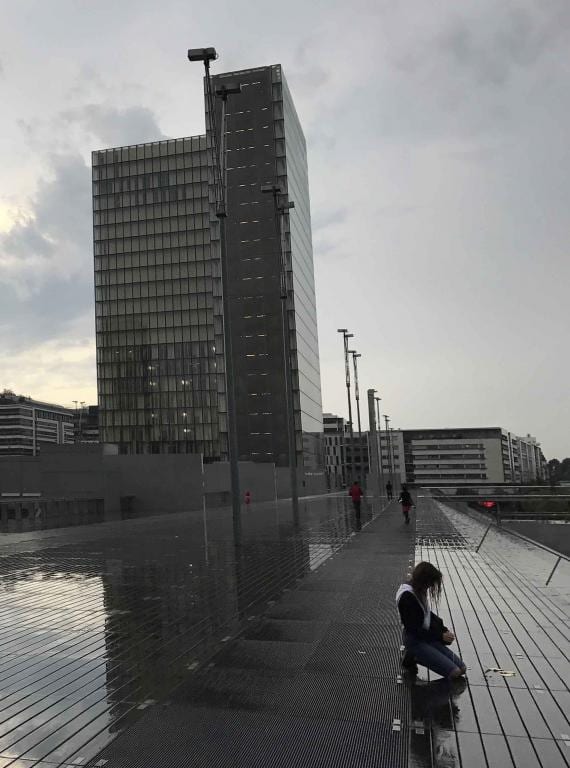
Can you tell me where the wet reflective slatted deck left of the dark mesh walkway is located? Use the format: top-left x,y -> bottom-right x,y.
0,498 -> 372,765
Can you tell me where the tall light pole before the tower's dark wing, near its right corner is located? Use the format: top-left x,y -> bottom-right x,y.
261,184 -> 299,523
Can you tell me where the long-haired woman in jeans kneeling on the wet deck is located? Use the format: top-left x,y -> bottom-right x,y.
396,562 -> 467,680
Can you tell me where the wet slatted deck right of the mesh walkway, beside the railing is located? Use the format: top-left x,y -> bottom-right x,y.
411,499 -> 570,768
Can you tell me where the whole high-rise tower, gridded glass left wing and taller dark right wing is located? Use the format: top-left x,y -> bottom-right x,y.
93,66 -> 322,474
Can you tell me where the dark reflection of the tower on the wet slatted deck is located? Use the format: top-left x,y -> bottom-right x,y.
101,513 -> 310,705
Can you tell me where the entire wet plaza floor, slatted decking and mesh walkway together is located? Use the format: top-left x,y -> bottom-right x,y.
0,497 -> 570,768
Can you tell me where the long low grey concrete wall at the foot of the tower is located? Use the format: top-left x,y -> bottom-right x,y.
0,444 -> 326,519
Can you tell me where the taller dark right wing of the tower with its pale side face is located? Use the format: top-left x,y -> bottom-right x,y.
211,65 -> 323,474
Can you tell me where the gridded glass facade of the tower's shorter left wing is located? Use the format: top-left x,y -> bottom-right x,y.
93,136 -> 223,459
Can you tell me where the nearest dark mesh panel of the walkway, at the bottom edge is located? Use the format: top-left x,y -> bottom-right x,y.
85,706 -> 406,768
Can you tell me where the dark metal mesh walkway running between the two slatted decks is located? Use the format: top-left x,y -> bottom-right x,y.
85,498 -> 414,768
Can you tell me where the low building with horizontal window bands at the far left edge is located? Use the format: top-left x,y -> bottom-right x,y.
0,390 -> 73,456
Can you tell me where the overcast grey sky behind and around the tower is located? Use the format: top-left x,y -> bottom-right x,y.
0,0 -> 570,458
